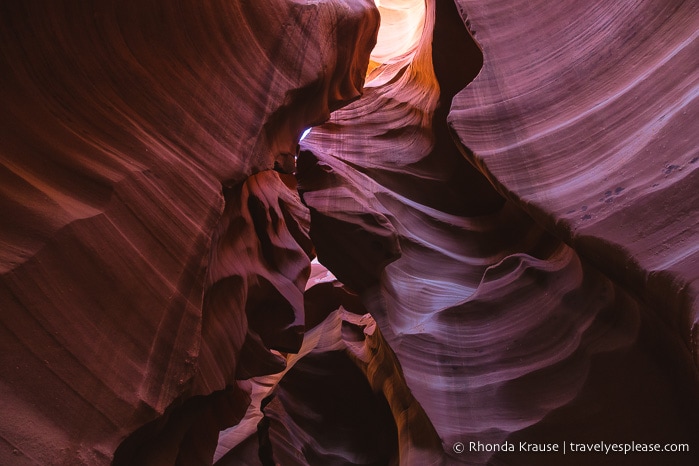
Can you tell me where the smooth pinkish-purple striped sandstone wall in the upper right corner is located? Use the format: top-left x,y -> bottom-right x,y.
450,0 -> 699,361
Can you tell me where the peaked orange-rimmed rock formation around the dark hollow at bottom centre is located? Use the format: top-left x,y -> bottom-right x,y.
215,263 -> 441,465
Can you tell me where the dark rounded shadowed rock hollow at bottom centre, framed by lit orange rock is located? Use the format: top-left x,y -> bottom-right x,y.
264,351 -> 398,466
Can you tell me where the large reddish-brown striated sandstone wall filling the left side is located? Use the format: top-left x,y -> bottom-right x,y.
0,0 -> 378,464
